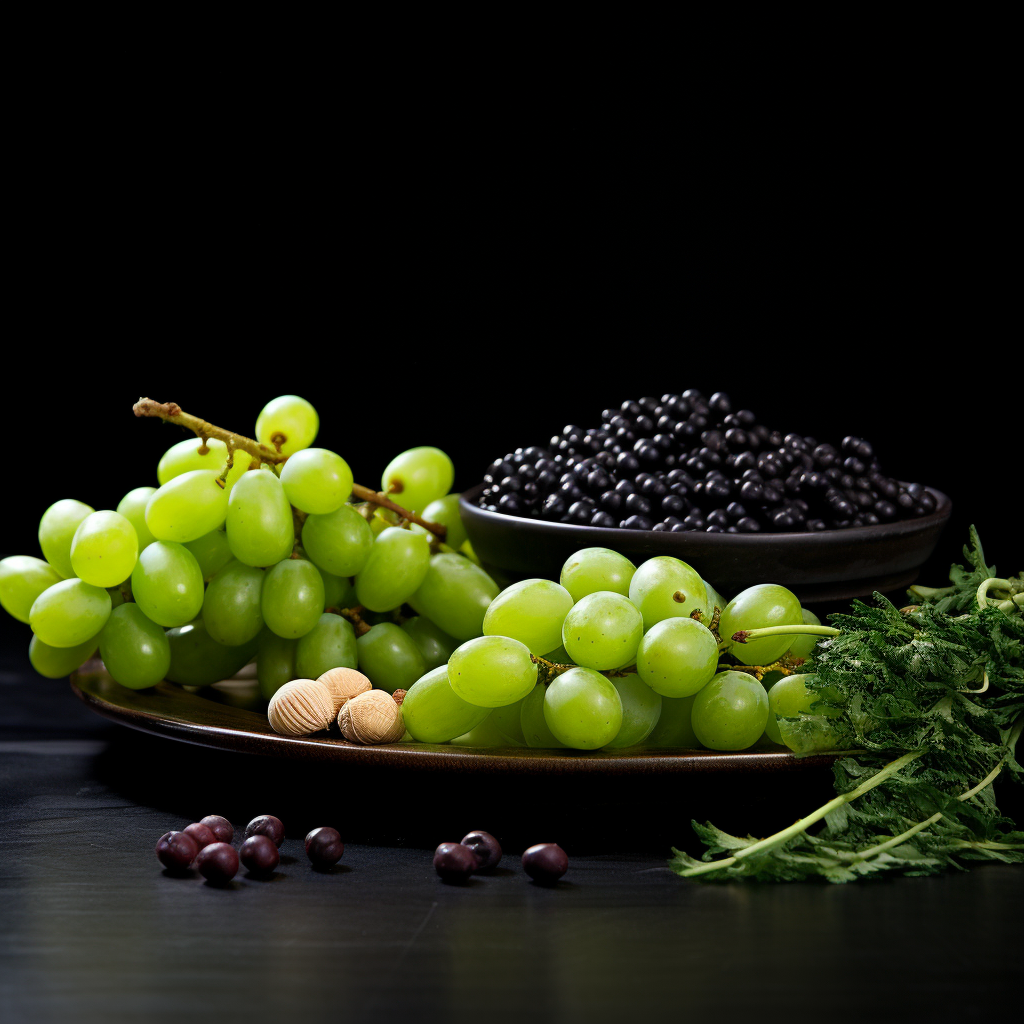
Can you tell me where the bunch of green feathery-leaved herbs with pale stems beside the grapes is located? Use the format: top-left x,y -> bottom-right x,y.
670,527 -> 1024,882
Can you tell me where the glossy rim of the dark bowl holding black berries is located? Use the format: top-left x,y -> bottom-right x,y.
459,480 -> 953,547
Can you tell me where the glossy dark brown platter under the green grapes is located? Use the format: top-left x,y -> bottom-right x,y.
71,662 -> 835,776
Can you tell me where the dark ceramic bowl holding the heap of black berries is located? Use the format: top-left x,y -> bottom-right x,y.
459,483 -> 952,604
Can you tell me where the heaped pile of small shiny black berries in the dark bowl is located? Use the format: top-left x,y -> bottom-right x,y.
479,390 -> 936,534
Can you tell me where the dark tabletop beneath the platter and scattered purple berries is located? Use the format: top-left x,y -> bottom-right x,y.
0,653 -> 1024,1024
